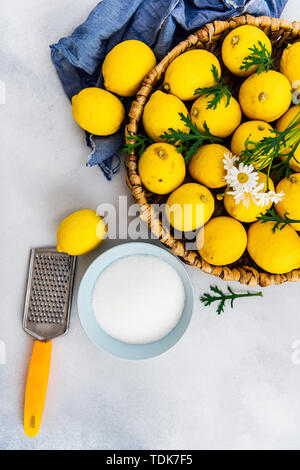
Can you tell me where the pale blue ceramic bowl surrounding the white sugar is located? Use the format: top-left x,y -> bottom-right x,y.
78,243 -> 194,359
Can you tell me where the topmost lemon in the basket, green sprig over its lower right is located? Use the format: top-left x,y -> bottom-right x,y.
222,25 -> 272,77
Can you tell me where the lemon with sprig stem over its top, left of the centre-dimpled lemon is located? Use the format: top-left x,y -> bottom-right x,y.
190,96 -> 242,138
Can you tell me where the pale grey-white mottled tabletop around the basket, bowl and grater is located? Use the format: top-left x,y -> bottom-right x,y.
0,0 -> 300,449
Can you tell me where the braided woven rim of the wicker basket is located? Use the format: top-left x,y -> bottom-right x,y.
125,15 -> 300,287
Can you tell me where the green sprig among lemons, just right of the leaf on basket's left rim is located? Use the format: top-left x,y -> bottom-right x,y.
160,113 -> 222,163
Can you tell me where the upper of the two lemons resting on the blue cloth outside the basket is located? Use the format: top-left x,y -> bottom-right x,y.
102,39 -> 156,96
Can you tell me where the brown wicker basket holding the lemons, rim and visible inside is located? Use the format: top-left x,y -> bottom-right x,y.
125,15 -> 300,287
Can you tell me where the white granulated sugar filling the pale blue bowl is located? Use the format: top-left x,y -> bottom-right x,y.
92,255 -> 185,344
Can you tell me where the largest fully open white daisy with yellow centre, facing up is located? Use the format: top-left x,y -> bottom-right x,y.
225,163 -> 258,193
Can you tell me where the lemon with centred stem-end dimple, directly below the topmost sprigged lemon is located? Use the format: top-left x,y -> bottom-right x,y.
239,70 -> 292,122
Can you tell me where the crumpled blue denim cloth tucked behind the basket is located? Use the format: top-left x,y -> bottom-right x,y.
50,0 -> 287,179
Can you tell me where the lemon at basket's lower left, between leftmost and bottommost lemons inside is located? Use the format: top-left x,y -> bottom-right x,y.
165,183 -> 215,232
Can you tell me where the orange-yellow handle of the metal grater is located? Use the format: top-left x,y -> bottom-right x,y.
24,341 -> 52,437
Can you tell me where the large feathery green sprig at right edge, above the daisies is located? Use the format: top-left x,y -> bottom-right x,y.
240,111 -> 300,191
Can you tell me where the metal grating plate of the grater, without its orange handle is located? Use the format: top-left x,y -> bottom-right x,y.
23,248 -> 76,341
